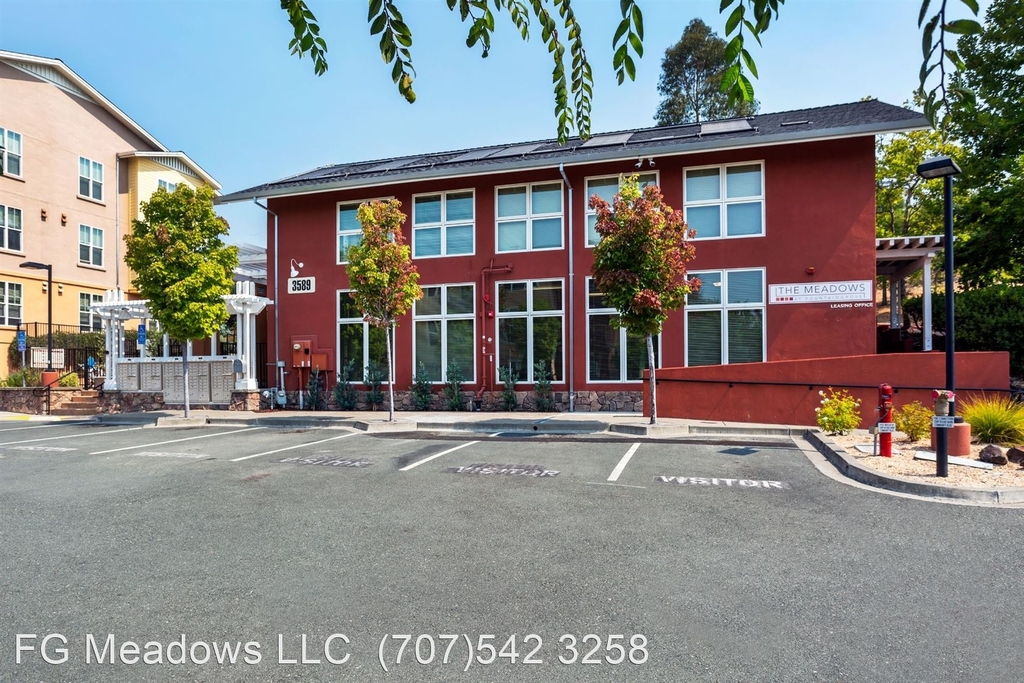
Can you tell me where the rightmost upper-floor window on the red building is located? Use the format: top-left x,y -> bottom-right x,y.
683,162 -> 765,240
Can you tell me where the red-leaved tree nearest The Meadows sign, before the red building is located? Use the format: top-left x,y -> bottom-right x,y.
590,175 -> 698,424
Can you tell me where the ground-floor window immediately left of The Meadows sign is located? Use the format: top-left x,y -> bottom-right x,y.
686,268 -> 765,367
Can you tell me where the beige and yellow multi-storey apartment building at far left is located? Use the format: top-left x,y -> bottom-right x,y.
0,50 -> 220,377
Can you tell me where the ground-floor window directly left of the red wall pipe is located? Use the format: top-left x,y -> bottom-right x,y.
413,285 -> 476,382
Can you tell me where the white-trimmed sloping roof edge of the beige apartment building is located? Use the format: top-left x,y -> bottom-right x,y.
0,50 -> 220,191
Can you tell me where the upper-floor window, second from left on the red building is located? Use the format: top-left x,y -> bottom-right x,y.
413,189 -> 474,258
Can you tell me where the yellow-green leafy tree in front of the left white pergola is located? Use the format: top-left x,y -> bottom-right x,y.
125,182 -> 239,417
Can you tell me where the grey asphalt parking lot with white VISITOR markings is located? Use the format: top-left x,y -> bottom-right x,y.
0,423 -> 1024,682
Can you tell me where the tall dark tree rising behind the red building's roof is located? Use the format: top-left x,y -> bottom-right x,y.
654,18 -> 758,126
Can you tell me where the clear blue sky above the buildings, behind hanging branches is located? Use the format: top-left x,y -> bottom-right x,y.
0,0 -> 974,245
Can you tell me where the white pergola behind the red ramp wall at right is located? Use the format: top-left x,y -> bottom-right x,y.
874,234 -> 945,351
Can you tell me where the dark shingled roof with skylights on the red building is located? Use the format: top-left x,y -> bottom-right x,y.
217,99 -> 930,204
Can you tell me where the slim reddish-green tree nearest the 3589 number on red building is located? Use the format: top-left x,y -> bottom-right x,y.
346,200 -> 423,421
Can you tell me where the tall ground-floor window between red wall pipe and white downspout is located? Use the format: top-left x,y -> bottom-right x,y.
498,280 -> 565,382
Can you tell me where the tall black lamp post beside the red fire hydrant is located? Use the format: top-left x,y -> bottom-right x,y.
918,157 -> 963,477
